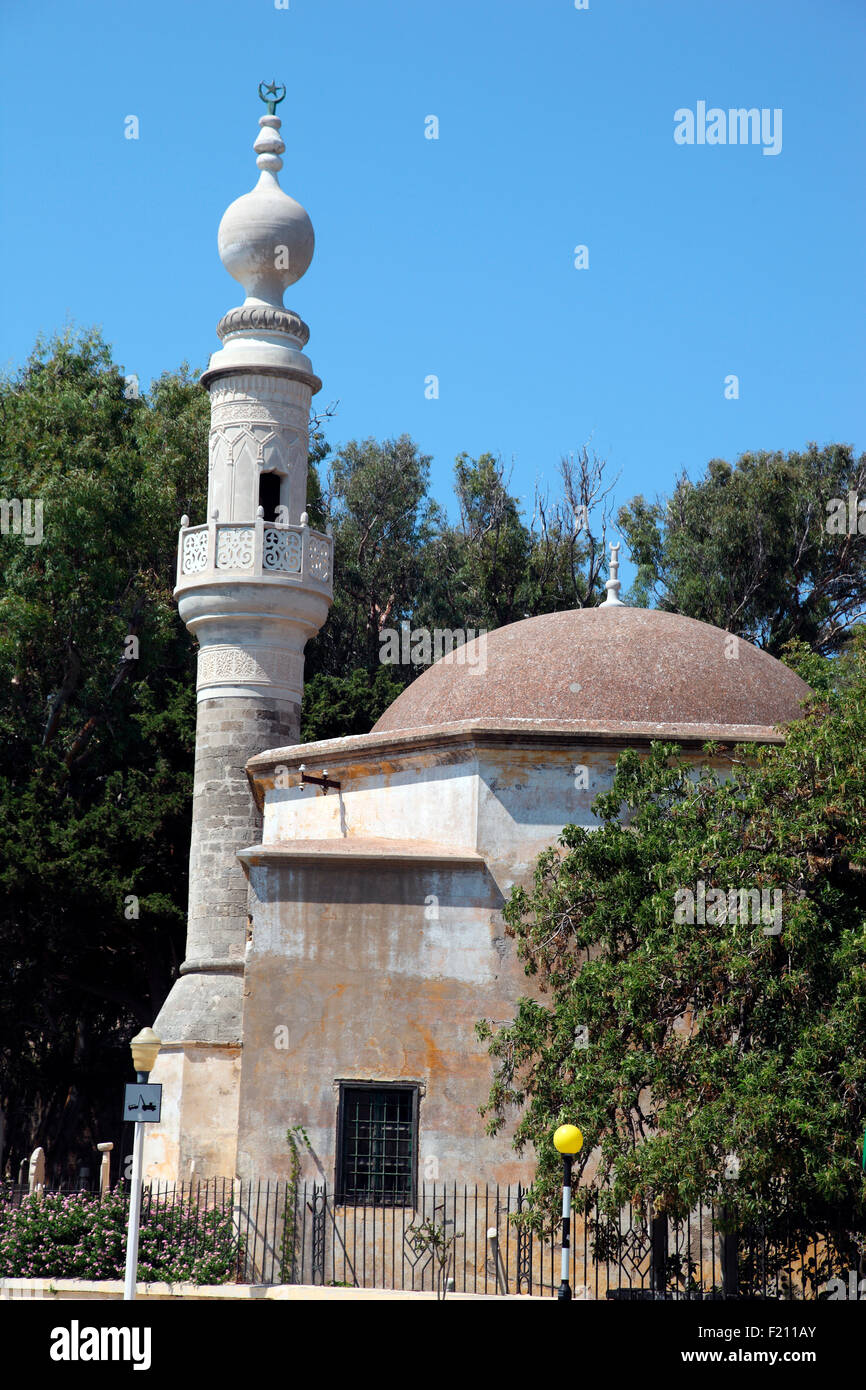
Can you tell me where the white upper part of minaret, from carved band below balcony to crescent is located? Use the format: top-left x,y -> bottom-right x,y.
175,82 -> 334,619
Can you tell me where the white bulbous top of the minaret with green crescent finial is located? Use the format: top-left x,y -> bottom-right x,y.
217,82 -> 316,309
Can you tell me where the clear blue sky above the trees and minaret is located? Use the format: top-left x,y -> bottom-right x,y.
0,0 -> 866,564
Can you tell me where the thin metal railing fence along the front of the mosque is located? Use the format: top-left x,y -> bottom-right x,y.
4,1179 -> 858,1300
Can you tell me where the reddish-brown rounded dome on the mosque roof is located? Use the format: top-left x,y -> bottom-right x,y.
373,605 -> 809,733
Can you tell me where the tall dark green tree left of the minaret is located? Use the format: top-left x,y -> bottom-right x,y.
0,332 -> 209,1178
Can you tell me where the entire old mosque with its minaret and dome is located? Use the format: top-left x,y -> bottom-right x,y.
145,89 -> 808,1205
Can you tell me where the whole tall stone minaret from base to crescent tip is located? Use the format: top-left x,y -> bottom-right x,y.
146,83 -> 334,1180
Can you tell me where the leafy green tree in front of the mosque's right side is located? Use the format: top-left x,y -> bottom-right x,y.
480,638 -> 866,1243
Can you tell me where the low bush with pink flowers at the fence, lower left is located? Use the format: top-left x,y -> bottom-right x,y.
0,1191 -> 240,1284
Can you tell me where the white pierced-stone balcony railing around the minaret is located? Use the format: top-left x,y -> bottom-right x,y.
177,517 -> 334,595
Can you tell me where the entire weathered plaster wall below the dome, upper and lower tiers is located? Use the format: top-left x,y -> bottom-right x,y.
238,737 -> 745,1184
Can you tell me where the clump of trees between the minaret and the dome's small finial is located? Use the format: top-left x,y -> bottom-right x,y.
306,435 -> 609,683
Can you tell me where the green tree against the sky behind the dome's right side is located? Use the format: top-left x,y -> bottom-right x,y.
619,443 -> 866,656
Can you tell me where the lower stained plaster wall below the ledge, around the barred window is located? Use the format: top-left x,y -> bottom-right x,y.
239,862 -> 520,1183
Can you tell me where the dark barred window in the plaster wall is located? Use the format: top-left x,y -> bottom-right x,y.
336,1083 -> 418,1207
